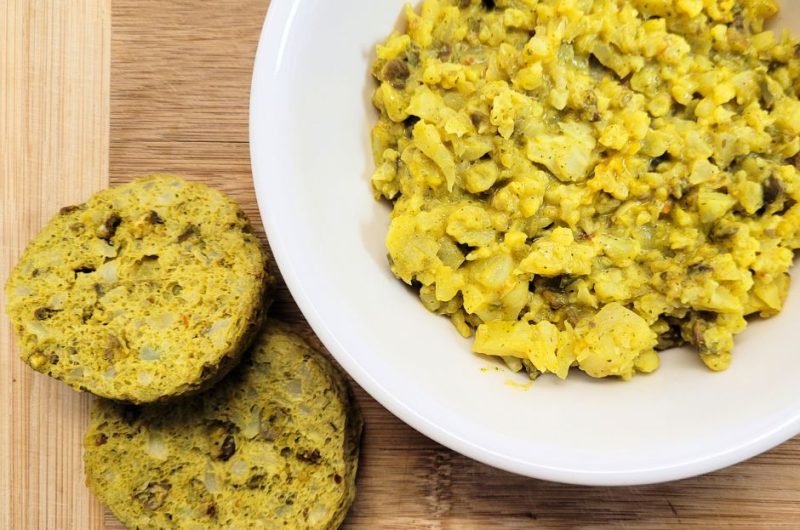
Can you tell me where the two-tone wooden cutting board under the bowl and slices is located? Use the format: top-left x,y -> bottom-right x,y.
0,0 -> 800,530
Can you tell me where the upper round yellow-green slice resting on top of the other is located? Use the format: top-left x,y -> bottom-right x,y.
6,175 -> 272,403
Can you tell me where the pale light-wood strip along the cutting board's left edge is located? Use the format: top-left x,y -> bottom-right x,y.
0,0 -> 111,529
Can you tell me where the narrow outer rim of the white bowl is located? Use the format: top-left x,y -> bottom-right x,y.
249,0 -> 800,486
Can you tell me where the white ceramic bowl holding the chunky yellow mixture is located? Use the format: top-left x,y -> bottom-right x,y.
250,0 -> 800,485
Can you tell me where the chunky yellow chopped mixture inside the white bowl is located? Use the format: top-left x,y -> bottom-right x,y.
372,0 -> 800,379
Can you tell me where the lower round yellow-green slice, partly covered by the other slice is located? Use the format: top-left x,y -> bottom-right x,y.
84,321 -> 362,529
